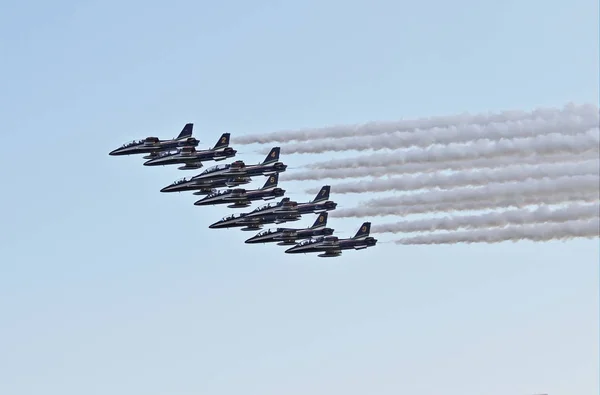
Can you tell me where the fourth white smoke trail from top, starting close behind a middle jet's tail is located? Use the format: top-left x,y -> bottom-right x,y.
280,151 -> 598,183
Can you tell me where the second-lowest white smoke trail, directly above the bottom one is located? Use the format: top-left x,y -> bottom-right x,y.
371,202 -> 600,233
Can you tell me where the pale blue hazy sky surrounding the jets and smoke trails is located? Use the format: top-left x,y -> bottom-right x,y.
0,0 -> 599,395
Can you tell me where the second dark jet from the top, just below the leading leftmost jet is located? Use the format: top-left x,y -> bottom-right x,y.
144,133 -> 237,170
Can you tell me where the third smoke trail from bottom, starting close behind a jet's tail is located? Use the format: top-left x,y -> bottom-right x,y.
329,180 -> 599,218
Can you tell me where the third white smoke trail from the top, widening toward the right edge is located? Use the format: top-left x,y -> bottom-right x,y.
307,128 -> 600,169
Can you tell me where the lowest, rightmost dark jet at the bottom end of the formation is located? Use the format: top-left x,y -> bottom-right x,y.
285,222 -> 377,258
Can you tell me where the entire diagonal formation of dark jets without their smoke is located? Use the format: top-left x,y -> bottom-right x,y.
109,123 -> 377,258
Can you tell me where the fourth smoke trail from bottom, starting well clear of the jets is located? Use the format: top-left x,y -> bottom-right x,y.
362,175 -> 600,207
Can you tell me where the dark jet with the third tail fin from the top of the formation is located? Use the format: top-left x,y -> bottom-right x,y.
194,147 -> 287,180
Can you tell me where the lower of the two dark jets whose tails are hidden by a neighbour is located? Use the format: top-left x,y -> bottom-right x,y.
209,198 -> 301,231
